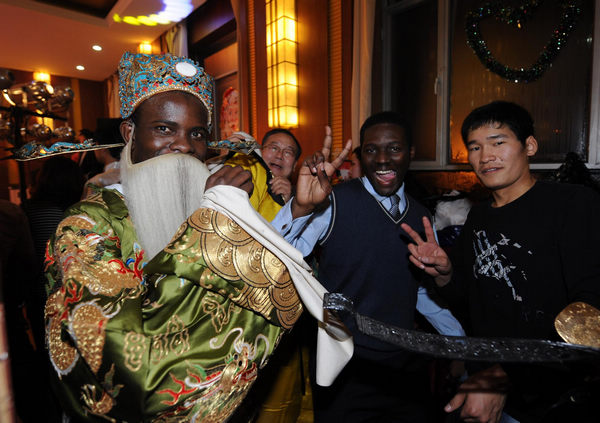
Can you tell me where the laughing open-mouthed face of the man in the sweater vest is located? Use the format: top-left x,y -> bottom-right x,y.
360,123 -> 414,196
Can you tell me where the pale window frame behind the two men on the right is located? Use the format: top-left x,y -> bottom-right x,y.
381,0 -> 600,170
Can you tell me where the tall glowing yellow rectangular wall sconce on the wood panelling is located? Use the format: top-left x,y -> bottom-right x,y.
266,0 -> 298,128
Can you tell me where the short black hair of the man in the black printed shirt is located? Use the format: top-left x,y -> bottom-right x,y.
460,101 -> 534,145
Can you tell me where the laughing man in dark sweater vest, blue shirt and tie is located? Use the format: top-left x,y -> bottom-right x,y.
273,112 -> 463,422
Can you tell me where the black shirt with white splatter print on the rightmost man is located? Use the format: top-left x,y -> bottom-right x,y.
440,181 -> 600,421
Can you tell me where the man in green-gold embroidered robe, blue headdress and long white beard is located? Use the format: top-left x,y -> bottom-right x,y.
45,53 -> 352,422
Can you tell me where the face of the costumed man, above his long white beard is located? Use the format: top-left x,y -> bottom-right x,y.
121,91 -> 209,163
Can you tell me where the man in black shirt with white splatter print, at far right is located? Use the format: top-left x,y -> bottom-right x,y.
403,101 -> 600,423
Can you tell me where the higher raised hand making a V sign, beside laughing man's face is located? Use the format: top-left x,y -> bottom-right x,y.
292,126 -> 352,218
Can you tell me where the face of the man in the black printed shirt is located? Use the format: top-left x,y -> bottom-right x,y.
467,123 -> 537,200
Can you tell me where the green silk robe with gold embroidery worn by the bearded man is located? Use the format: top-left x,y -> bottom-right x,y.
45,190 -> 303,422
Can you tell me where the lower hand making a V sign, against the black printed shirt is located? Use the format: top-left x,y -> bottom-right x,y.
401,217 -> 452,286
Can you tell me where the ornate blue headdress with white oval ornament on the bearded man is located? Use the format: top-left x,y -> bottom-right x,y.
119,52 -> 213,128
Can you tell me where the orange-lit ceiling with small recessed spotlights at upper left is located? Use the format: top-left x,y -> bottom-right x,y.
0,0 -> 206,81
